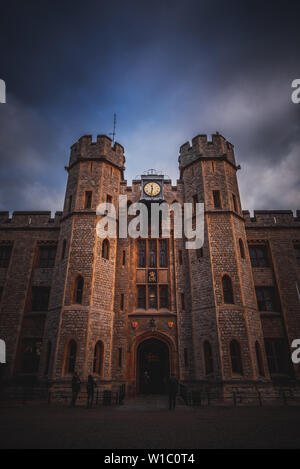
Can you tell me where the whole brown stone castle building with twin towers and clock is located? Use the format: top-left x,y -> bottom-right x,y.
0,133 -> 300,395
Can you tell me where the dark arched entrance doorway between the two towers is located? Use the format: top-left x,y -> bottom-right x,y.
137,339 -> 170,394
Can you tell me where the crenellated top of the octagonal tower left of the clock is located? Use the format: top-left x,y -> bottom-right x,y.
70,135 -> 125,170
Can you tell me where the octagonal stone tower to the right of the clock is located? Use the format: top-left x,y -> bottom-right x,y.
179,133 -> 267,390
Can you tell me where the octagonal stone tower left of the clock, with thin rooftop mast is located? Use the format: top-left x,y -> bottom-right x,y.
44,135 -> 125,383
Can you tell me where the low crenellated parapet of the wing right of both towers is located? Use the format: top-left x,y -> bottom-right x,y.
243,210 -> 300,228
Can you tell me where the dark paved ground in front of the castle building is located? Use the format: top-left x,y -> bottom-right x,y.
0,397 -> 300,449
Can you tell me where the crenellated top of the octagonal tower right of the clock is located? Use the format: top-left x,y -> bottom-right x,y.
178,132 -> 235,169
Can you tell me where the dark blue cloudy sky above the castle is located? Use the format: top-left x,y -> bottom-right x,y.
0,0 -> 300,211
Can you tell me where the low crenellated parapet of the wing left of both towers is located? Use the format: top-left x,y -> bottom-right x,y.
0,211 -> 62,228
